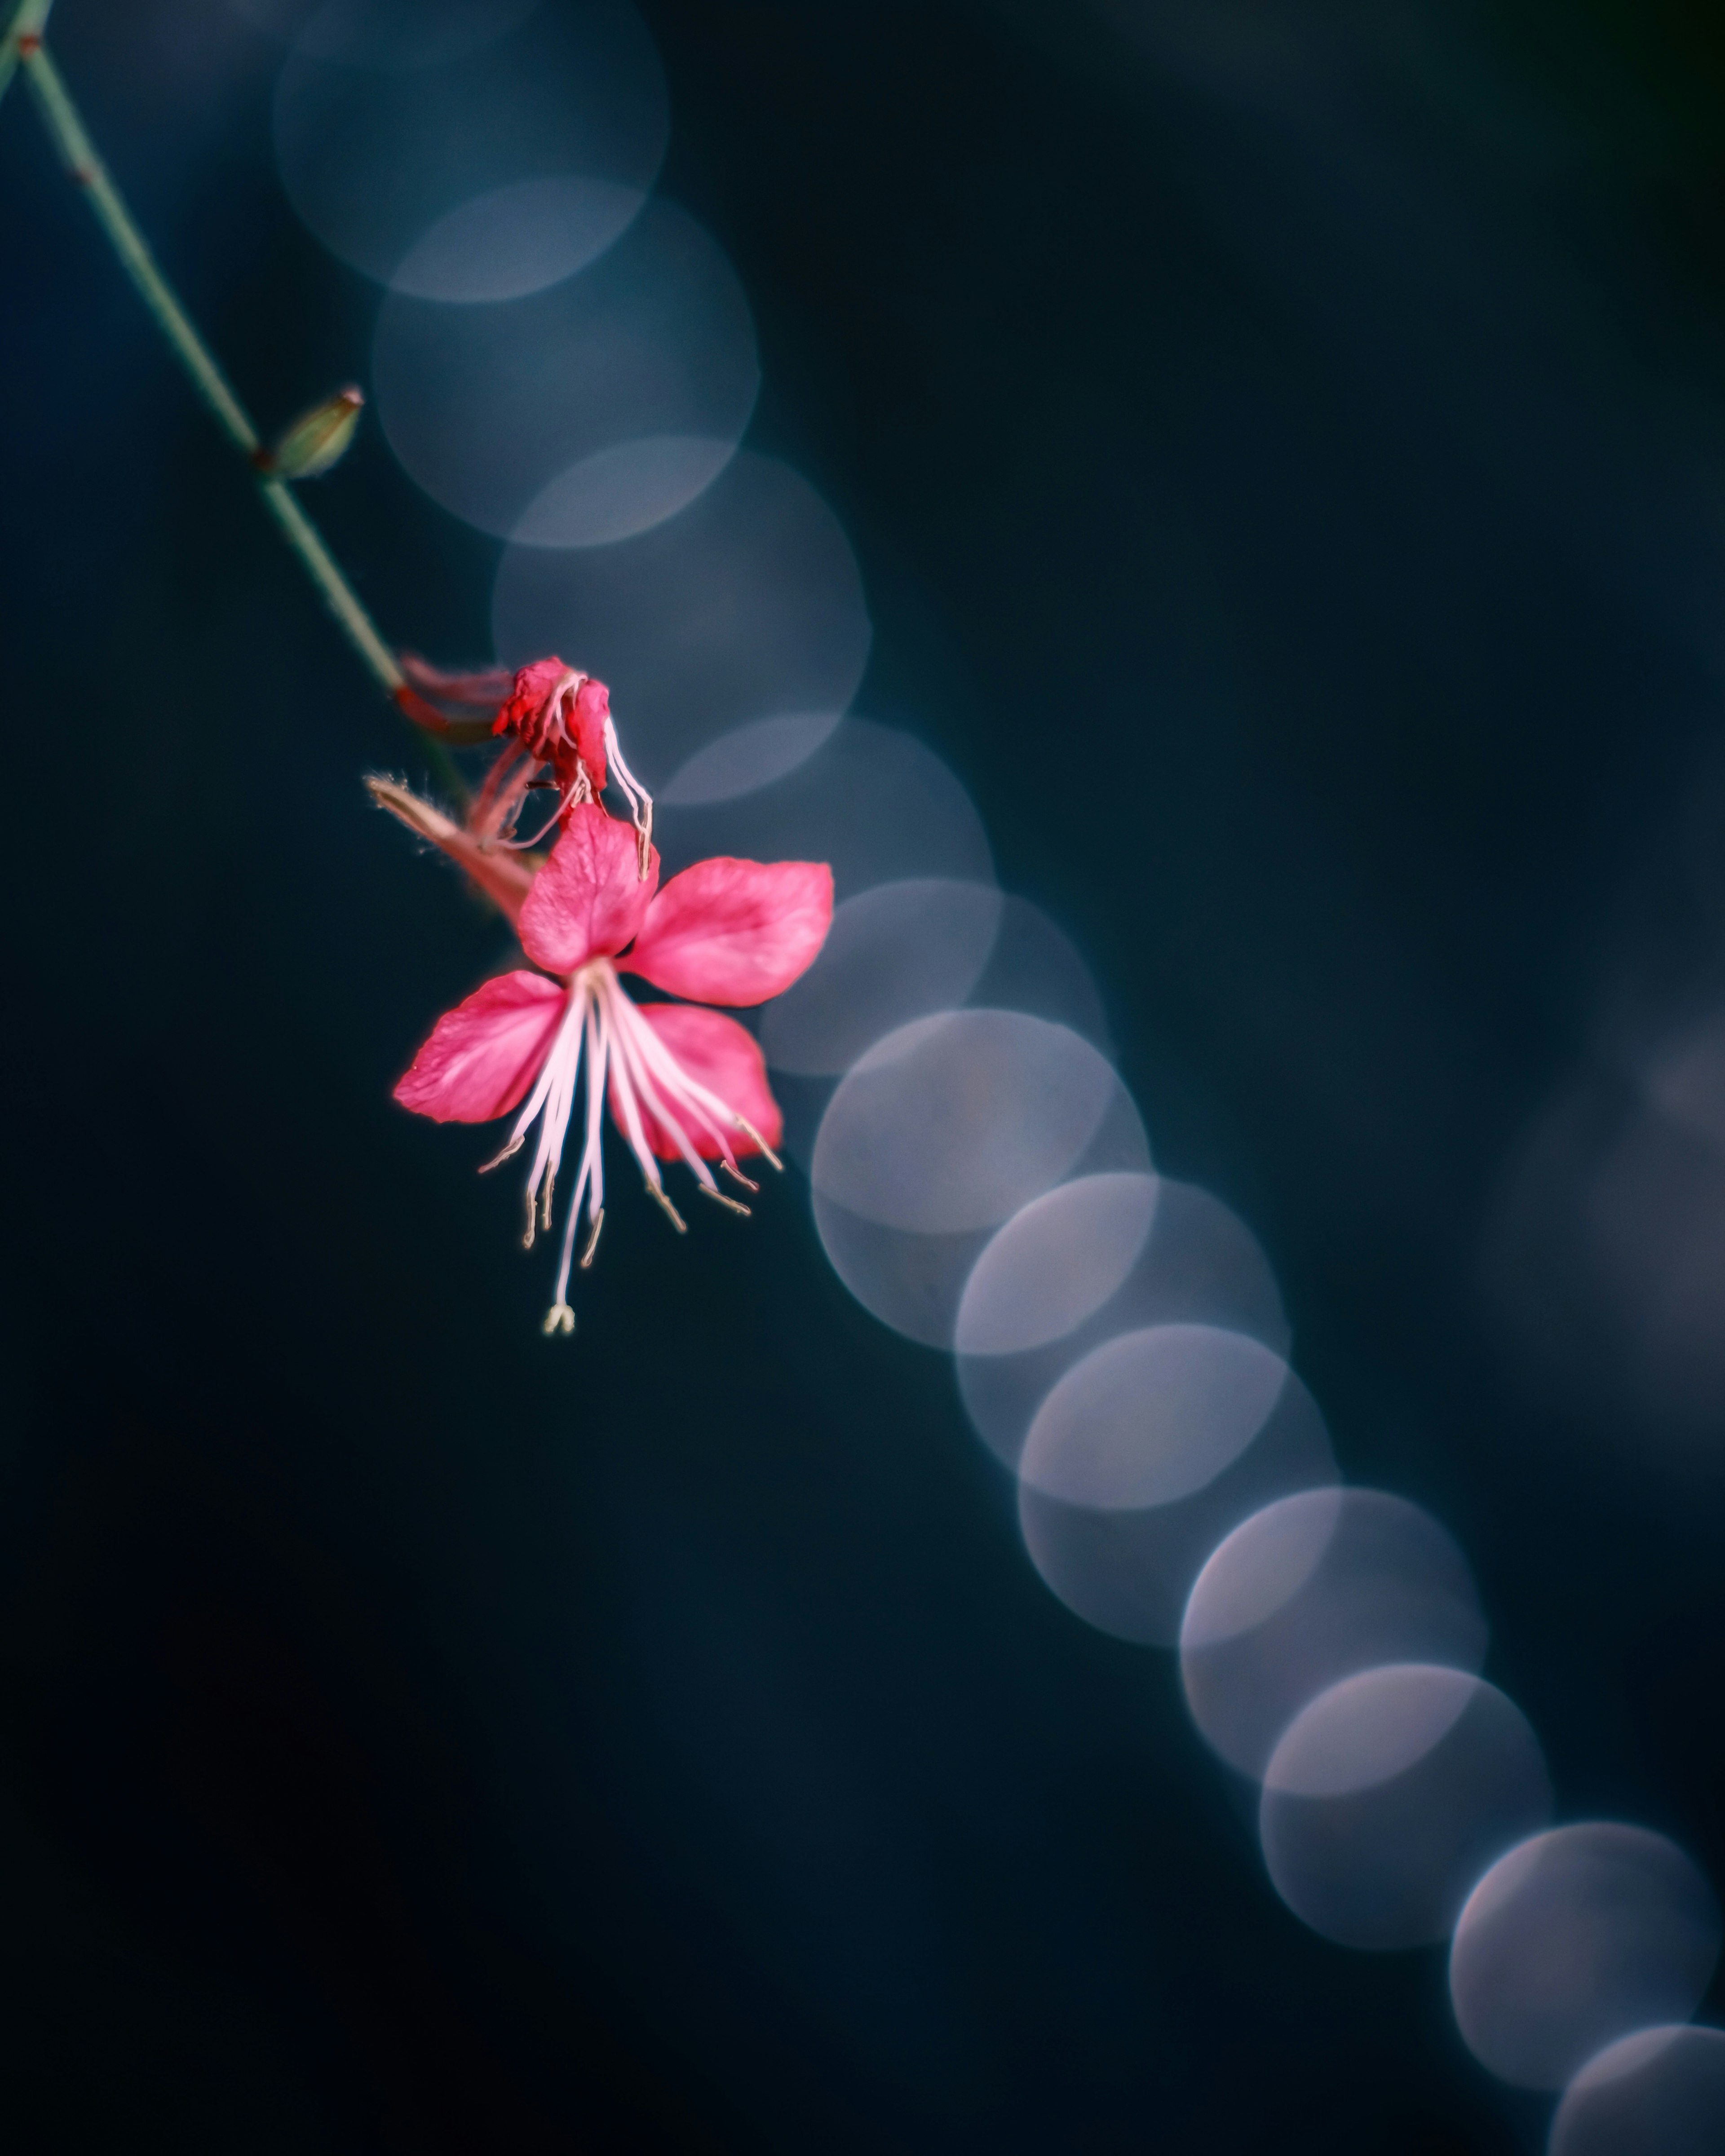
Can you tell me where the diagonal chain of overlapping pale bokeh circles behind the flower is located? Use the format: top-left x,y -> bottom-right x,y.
260,0 -> 1725,2156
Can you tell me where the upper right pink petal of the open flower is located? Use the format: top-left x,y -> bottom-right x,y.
623,854 -> 832,1003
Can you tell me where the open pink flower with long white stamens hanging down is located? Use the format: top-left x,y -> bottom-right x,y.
392,793 -> 832,1332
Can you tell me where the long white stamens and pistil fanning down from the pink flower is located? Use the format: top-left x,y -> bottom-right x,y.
487,957 -> 778,1334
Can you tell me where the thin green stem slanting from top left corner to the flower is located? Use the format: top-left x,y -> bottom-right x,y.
0,21 -> 466,791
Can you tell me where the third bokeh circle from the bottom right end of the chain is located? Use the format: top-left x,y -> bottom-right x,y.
1257,1662 -> 1550,1951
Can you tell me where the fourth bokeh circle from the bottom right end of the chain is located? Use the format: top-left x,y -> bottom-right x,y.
1180,1488 -> 1486,1781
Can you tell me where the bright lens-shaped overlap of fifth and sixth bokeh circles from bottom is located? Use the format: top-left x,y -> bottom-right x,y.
1018,1326 -> 1287,1511
